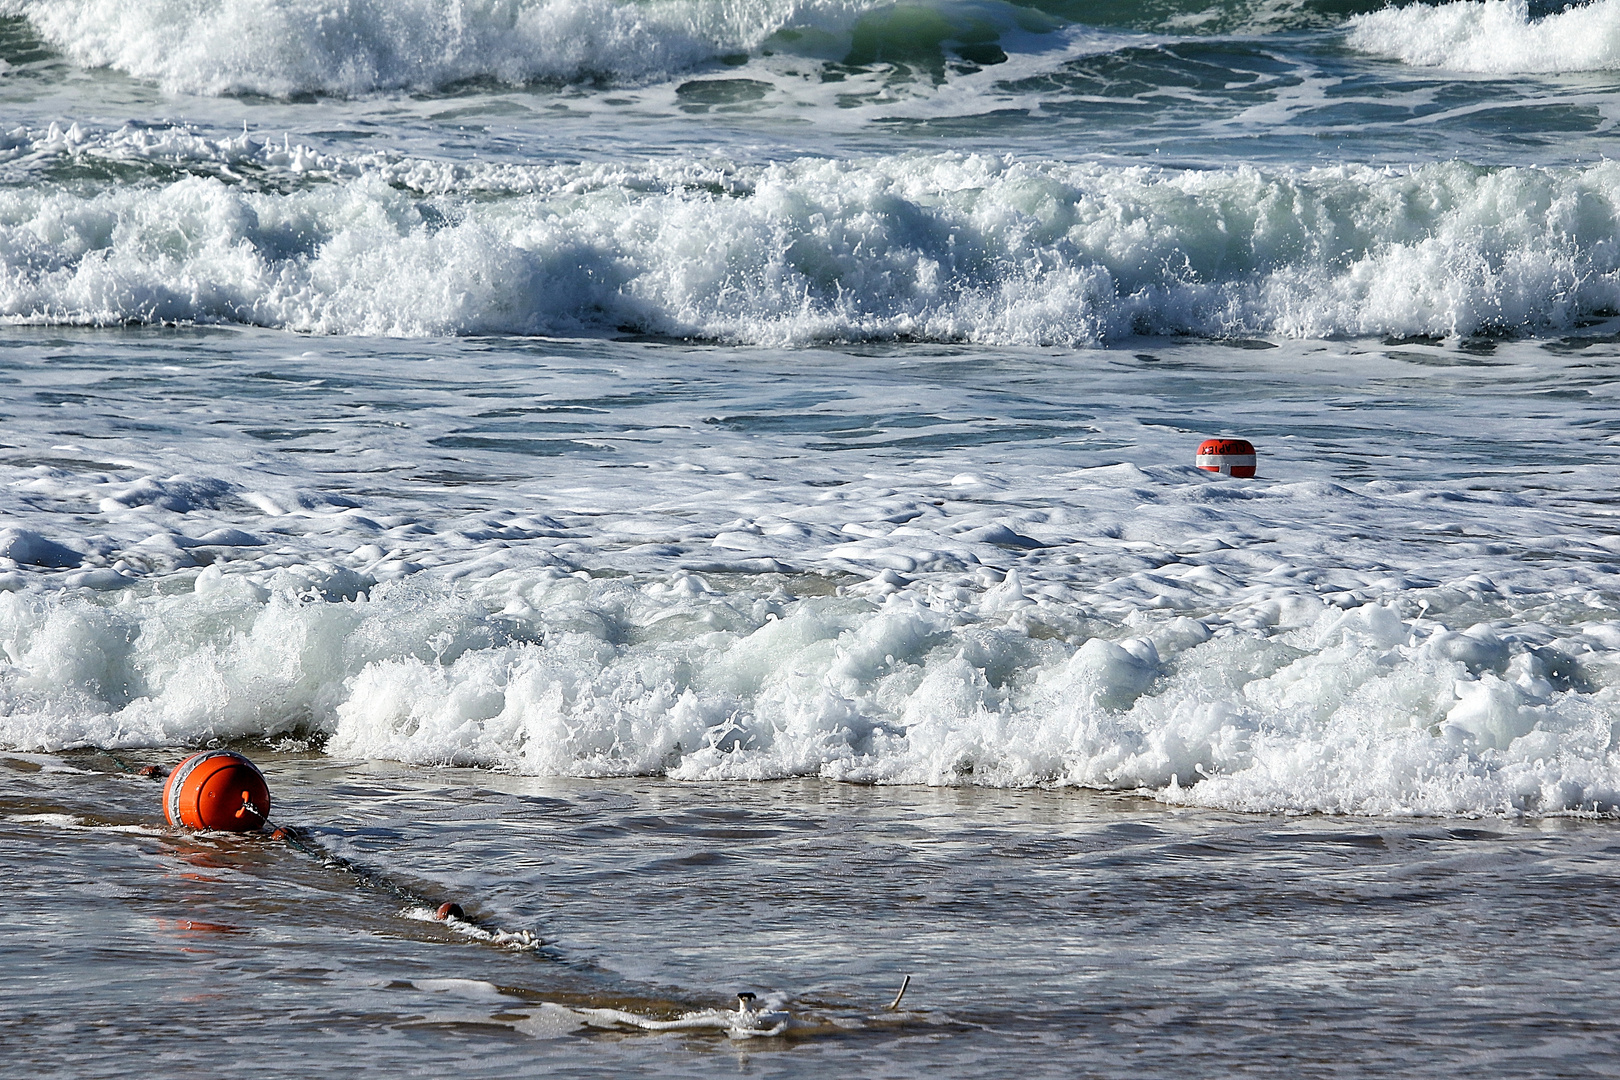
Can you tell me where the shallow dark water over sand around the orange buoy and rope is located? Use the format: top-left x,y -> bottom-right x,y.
0,751 -> 1620,1077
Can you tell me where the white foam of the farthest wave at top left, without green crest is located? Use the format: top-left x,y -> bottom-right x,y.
0,0 -> 887,96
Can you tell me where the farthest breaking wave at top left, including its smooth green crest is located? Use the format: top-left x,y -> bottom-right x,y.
0,0 -> 1101,97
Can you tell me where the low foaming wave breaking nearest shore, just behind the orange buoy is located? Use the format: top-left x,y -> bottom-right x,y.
0,568 -> 1620,814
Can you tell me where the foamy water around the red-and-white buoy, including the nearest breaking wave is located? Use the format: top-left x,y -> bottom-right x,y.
0,330 -> 1620,814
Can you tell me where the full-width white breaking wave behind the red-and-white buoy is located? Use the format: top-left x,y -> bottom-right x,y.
0,139 -> 1620,345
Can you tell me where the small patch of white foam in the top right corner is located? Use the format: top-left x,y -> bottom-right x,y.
1349,0 -> 1620,73
